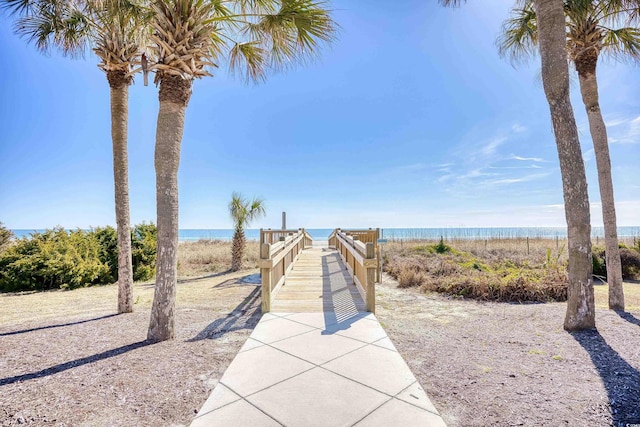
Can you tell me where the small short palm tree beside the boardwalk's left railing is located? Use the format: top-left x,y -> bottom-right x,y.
229,192 -> 265,271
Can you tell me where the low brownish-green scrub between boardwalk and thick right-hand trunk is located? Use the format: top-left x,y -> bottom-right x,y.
384,239 -> 567,302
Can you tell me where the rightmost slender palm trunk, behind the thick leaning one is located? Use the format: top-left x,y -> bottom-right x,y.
575,57 -> 624,310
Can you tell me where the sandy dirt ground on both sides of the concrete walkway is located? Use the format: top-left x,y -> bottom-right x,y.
0,271 -> 640,426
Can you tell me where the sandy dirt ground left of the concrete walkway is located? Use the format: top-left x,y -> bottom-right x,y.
0,272 -> 262,426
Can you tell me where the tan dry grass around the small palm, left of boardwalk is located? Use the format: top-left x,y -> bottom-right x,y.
178,240 -> 260,277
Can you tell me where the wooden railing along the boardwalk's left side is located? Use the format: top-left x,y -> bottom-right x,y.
259,228 -> 313,313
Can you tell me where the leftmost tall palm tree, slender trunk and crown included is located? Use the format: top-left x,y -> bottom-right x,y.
2,0 -> 148,313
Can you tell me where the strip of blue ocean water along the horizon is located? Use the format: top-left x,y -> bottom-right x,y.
12,226 -> 640,242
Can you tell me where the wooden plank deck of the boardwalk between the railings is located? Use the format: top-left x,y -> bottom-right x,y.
271,247 -> 365,315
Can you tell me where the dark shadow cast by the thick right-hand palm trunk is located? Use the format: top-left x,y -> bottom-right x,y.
571,330 -> 640,427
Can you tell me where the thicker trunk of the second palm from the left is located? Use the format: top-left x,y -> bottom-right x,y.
147,75 -> 191,341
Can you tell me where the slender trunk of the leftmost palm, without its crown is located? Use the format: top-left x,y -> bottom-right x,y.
107,71 -> 133,313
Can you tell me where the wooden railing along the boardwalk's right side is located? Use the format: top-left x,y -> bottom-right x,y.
329,229 -> 378,313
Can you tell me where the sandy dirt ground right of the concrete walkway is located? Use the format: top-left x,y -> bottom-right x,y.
376,278 -> 640,427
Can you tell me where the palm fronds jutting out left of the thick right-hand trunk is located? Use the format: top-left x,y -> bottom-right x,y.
496,3 -> 538,63
